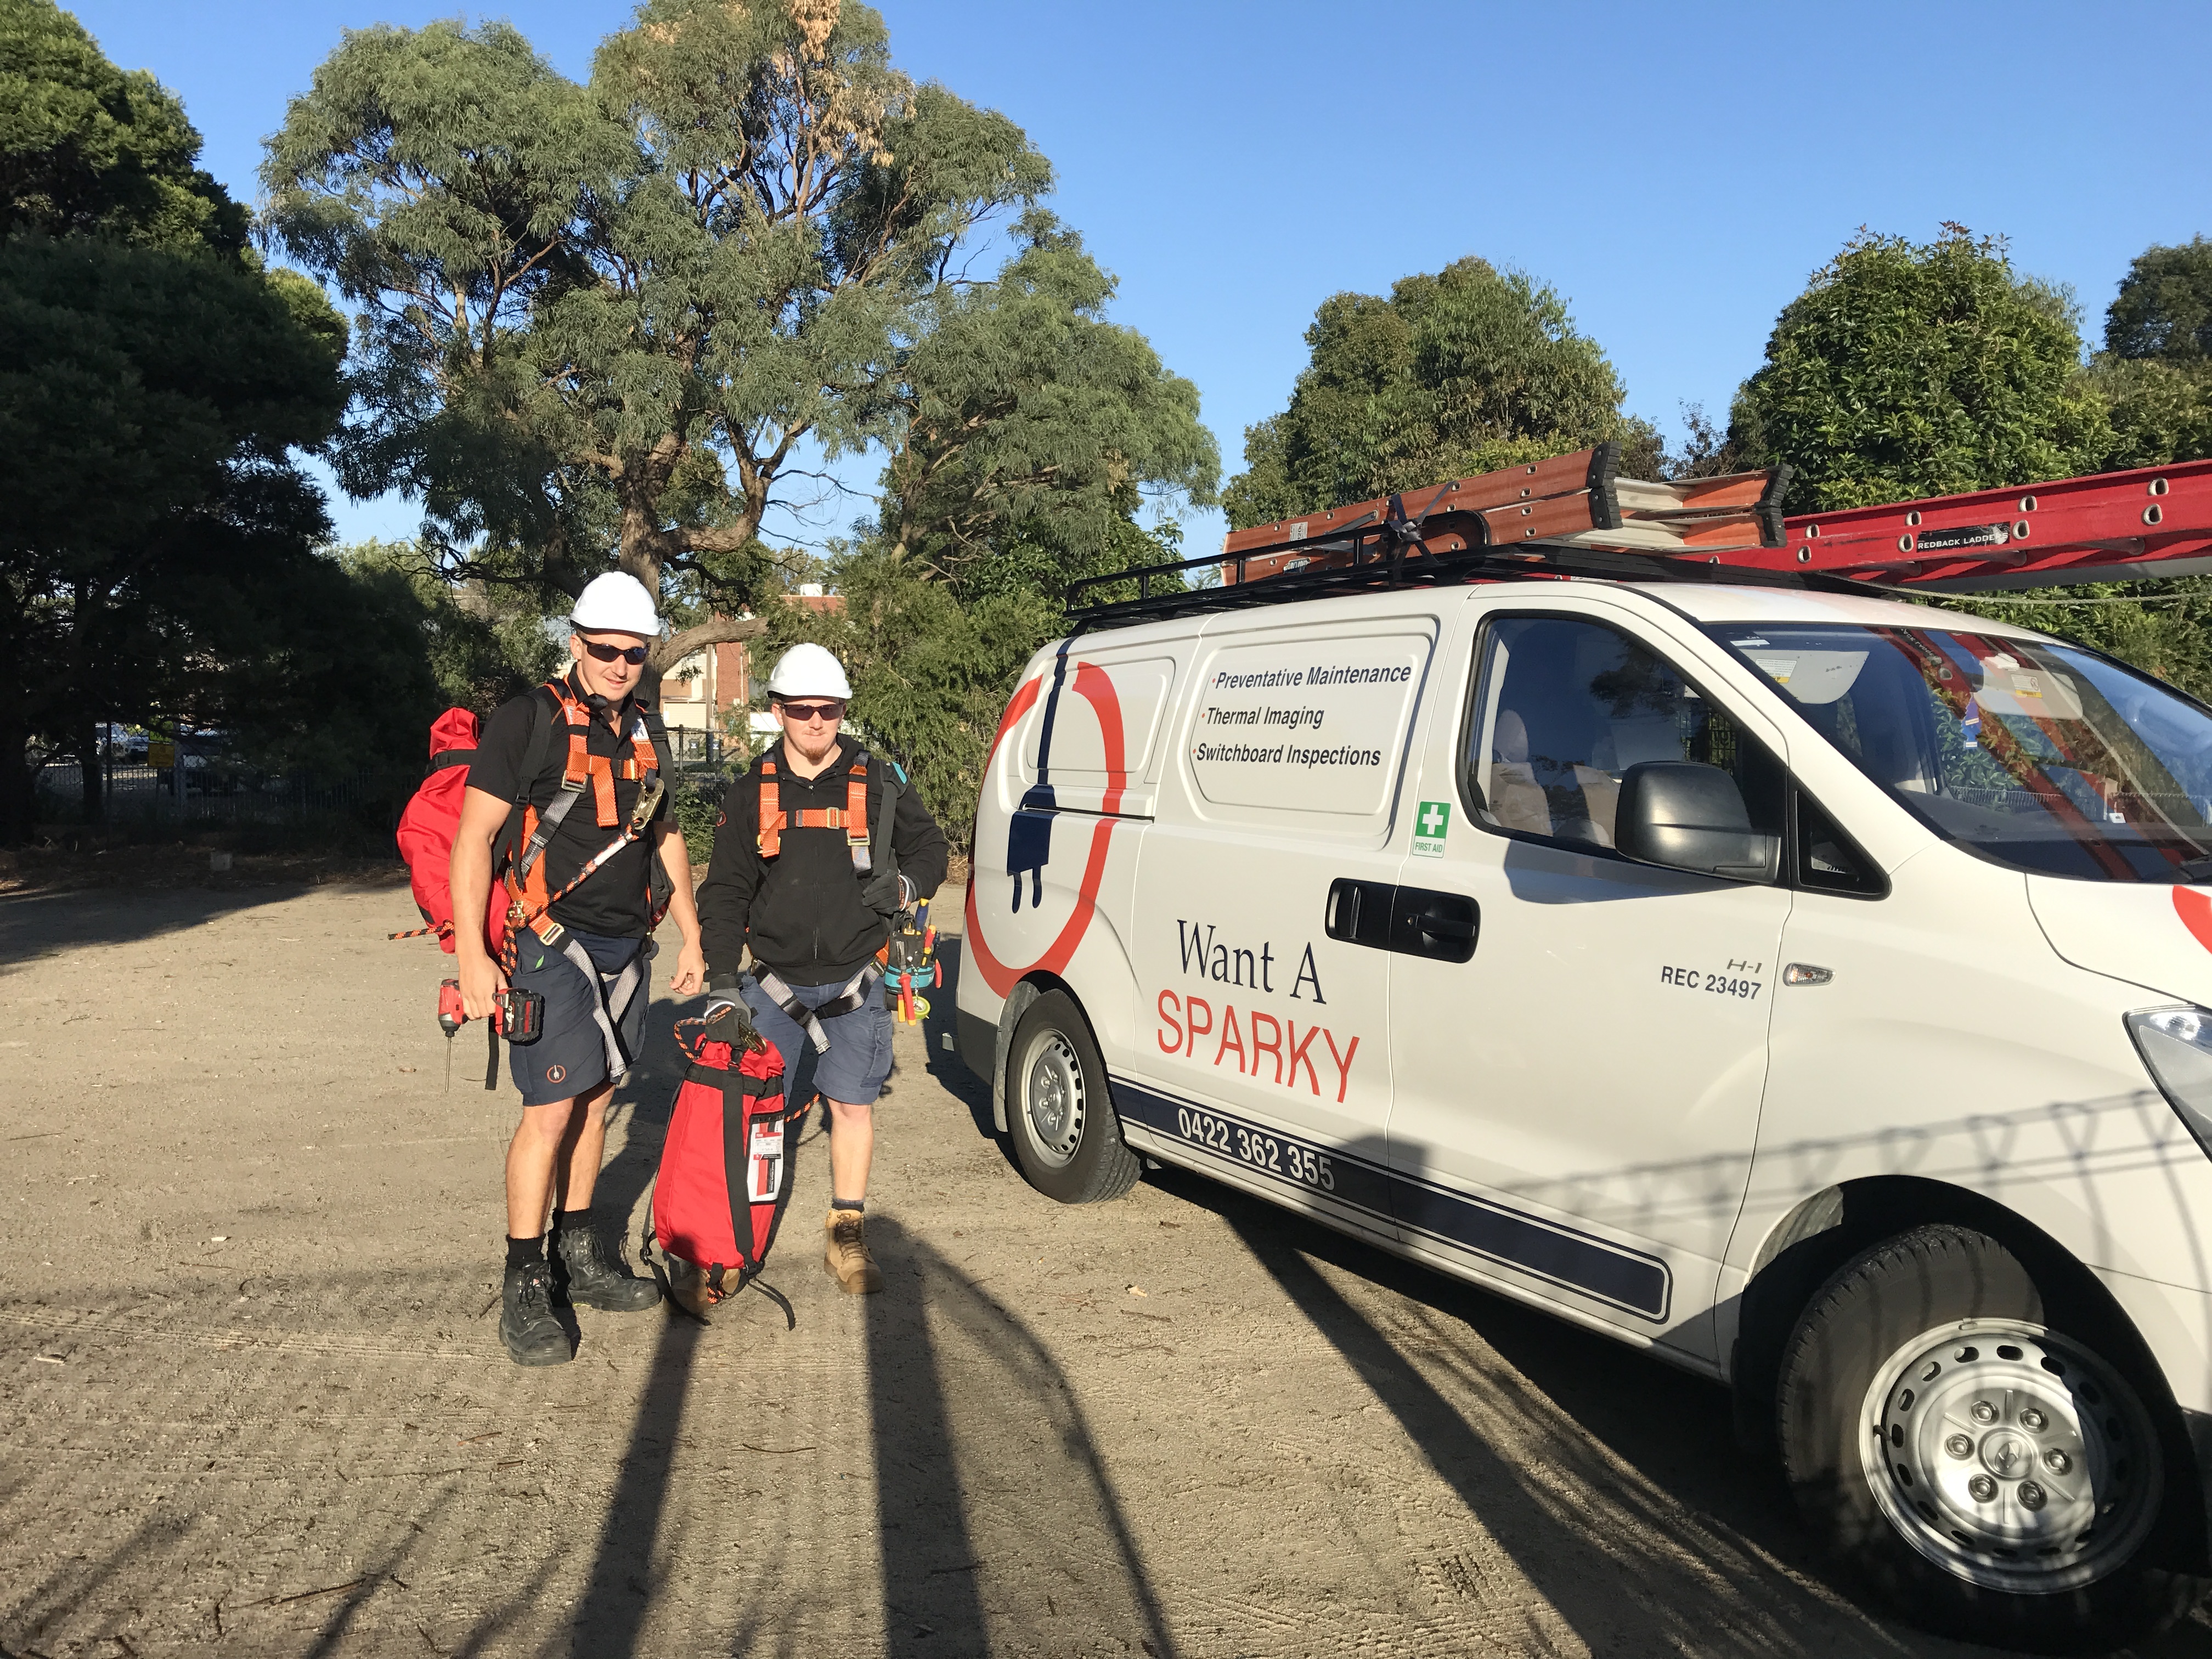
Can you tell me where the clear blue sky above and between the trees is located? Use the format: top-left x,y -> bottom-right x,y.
60,0 -> 2212,551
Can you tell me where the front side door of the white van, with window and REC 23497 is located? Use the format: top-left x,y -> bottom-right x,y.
1389,595 -> 1790,1361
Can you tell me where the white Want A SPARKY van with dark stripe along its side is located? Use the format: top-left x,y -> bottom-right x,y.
958,579 -> 2212,1648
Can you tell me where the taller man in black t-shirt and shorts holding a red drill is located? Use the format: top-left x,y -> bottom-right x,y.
452,573 -> 706,1365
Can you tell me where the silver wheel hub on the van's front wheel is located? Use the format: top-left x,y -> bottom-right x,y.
1860,1318 -> 2161,1595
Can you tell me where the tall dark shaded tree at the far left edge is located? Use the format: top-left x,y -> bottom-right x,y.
0,0 -> 345,840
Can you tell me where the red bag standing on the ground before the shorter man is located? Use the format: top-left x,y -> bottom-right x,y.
639,1018 -> 812,1323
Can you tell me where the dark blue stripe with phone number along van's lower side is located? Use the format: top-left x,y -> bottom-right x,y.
1108,1077 -> 1672,1323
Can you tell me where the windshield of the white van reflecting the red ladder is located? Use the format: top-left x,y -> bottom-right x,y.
1708,624 -> 2212,883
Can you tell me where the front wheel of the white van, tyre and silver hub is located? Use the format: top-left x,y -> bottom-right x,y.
1776,1226 -> 2201,1652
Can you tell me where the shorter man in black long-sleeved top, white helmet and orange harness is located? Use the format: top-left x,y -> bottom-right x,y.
699,646 -> 947,1294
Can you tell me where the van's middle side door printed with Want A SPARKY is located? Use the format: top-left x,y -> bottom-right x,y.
1115,595 -> 1458,1237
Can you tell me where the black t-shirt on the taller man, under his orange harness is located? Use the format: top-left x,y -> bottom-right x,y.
469,679 -> 668,938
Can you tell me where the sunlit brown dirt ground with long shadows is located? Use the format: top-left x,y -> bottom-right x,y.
0,870 -> 2212,1659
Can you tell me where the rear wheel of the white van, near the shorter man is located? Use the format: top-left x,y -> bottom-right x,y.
1007,991 -> 1144,1203
